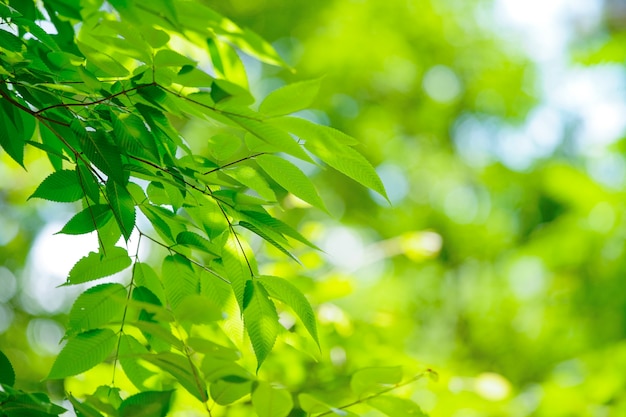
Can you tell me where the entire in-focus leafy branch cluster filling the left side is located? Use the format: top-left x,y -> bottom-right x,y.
0,0 -> 434,417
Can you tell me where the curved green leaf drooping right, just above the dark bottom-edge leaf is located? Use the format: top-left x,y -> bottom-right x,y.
142,352 -> 207,402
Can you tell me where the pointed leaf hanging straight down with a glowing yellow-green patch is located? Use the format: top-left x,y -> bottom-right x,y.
243,280 -> 280,371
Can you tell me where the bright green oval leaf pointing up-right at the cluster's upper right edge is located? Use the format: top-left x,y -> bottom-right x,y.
259,78 -> 321,116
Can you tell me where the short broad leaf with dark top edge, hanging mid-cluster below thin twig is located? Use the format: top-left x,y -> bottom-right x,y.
161,255 -> 200,310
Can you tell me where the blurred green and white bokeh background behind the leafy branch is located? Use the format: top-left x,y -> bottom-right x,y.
0,0 -> 626,417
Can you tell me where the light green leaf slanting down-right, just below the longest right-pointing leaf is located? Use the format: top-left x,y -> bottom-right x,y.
256,155 -> 326,211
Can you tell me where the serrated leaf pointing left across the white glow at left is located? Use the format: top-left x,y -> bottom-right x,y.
65,246 -> 131,285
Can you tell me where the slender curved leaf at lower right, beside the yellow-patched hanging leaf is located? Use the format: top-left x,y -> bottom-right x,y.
258,275 -> 320,347
